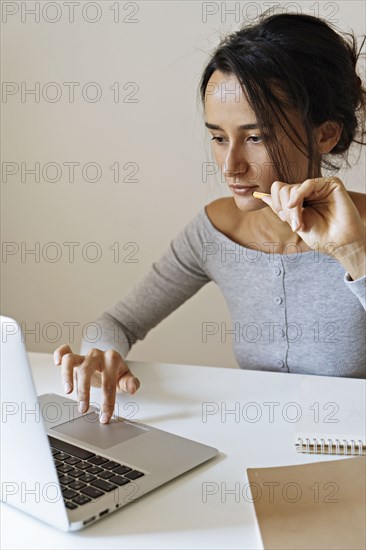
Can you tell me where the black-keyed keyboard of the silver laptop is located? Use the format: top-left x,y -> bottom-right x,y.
48,436 -> 145,510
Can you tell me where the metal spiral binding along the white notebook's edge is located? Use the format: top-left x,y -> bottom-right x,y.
296,437 -> 366,455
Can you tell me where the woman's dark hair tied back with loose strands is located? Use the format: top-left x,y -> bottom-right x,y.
199,10 -> 366,183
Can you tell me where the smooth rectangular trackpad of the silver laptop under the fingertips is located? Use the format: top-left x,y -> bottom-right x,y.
51,412 -> 149,449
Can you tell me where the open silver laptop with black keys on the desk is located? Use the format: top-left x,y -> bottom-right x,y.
0,316 -> 218,531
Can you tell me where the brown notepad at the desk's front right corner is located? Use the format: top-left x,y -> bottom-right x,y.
247,456 -> 366,550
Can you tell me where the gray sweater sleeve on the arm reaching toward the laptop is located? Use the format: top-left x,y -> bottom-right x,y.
80,212 -> 212,358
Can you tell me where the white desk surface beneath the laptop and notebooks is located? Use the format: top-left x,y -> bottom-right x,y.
1,353 -> 361,549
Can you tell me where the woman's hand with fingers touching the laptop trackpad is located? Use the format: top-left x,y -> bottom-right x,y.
53,345 -> 140,424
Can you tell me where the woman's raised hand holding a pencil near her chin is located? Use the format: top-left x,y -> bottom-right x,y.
262,177 -> 365,257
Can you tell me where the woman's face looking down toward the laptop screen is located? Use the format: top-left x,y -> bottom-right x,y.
205,71 -> 314,211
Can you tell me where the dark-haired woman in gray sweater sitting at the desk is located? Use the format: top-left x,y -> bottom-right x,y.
54,14 -> 366,423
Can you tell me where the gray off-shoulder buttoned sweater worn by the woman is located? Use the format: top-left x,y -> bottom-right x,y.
81,208 -> 366,378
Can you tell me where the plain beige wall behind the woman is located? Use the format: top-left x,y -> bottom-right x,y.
1,0 -> 365,367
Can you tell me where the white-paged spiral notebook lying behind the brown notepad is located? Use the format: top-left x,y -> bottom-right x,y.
295,376 -> 366,455
